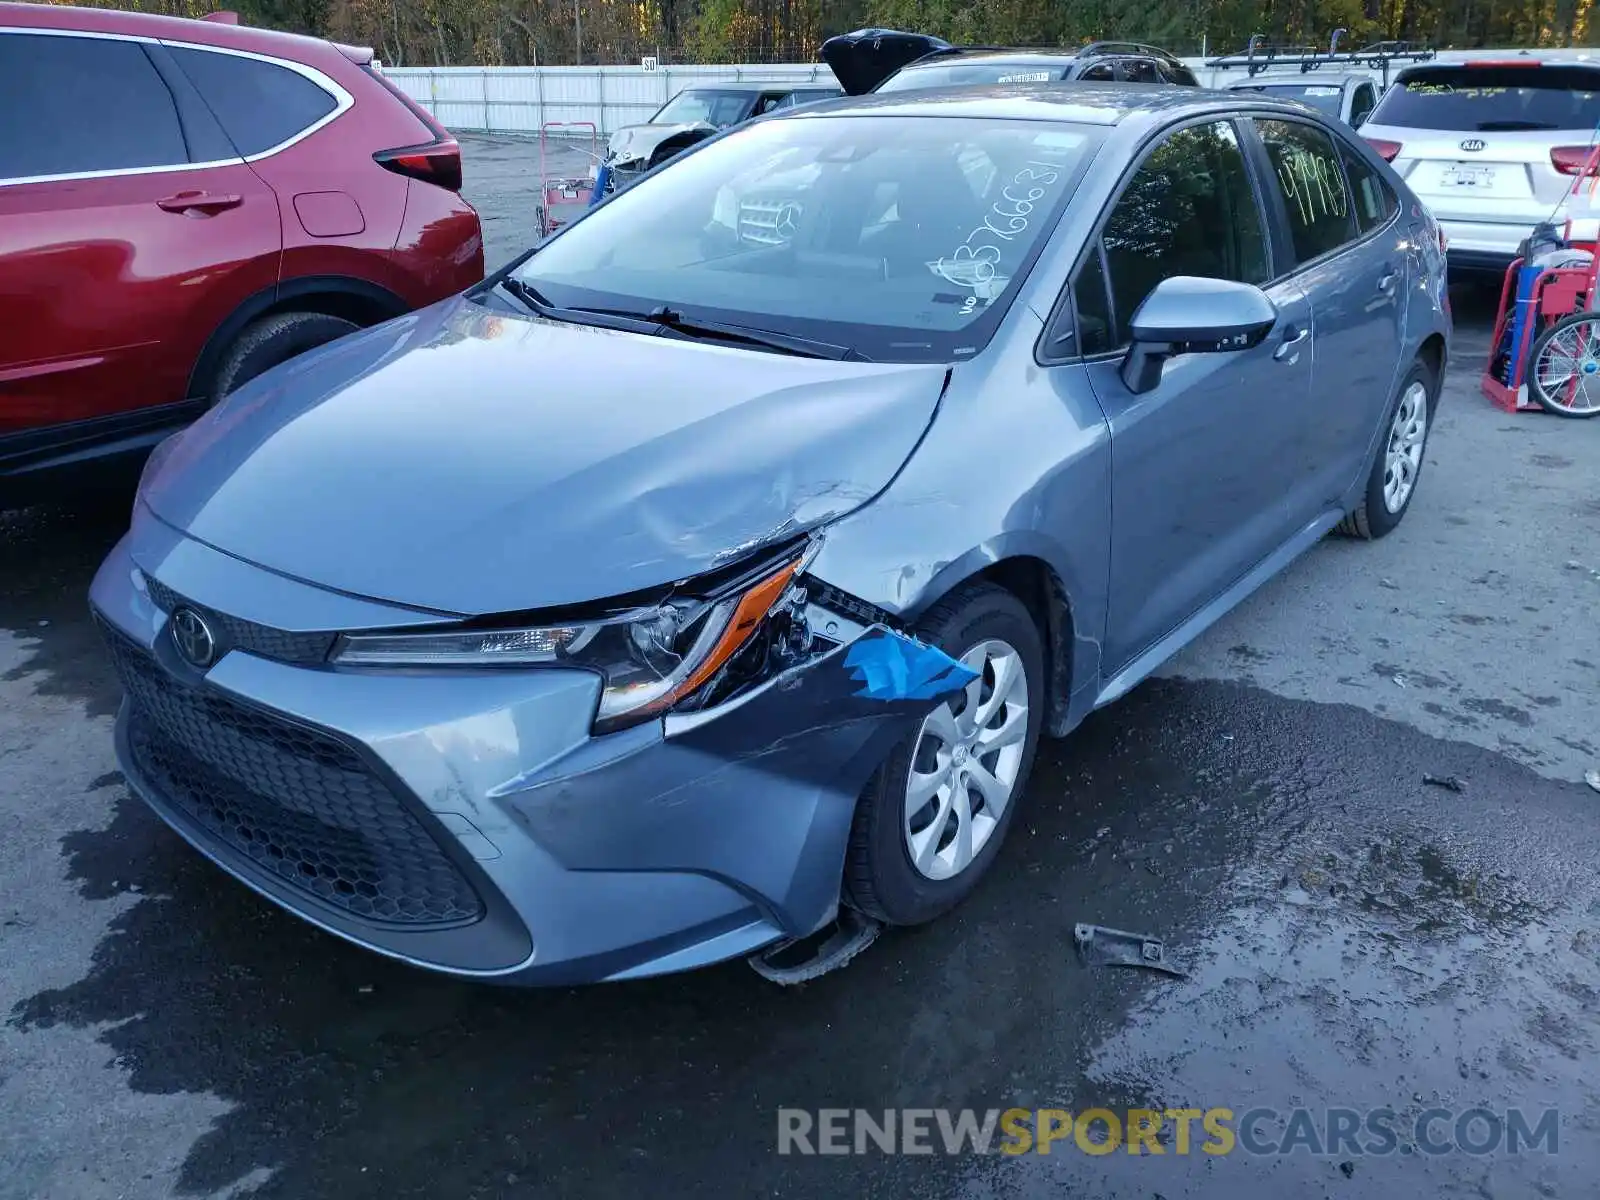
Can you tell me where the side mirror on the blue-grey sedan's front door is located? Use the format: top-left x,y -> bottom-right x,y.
1122,275 -> 1278,394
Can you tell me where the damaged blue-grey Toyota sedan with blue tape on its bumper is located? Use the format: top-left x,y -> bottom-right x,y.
93,86 -> 1448,984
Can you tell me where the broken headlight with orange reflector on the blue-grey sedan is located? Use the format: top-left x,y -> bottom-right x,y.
333,552 -> 810,733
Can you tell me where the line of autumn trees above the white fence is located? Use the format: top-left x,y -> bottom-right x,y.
31,0 -> 1600,66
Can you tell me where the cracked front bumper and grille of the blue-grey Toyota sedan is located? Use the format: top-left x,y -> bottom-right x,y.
91,514 -> 934,984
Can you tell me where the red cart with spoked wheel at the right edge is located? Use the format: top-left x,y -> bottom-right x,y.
1482,144 -> 1600,418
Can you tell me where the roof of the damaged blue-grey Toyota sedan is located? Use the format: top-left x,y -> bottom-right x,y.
779,83 -> 1307,125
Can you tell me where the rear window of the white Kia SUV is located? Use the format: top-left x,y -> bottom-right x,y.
1371,66 -> 1600,133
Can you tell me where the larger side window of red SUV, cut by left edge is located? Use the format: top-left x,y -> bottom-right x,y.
0,34 -> 189,179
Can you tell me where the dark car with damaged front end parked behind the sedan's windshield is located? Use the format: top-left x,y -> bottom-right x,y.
605,82 -> 843,192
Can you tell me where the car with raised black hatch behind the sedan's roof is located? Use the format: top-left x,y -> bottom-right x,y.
821,29 -> 1200,96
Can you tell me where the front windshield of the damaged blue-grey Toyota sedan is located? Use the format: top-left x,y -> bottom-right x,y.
517,115 -> 1102,362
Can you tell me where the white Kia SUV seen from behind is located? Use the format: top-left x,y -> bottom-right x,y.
1362,54 -> 1600,270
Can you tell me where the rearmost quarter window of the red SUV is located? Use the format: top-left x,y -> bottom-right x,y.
171,46 -> 338,157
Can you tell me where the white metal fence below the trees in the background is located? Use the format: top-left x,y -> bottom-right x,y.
384,50 -> 1600,134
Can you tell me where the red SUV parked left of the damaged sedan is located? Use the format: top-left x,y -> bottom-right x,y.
0,3 -> 483,506
